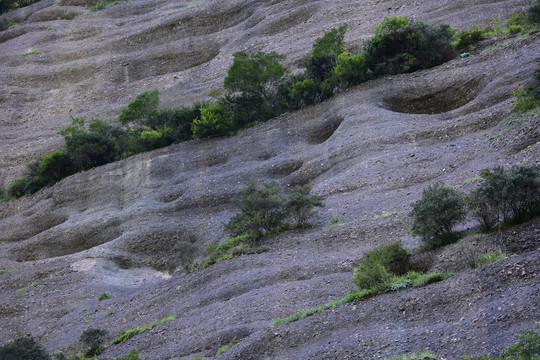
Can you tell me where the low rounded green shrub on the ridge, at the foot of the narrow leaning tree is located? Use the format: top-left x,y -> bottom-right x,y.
288,78 -> 332,109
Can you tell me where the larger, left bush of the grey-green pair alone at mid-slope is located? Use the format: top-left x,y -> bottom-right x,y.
225,180 -> 287,237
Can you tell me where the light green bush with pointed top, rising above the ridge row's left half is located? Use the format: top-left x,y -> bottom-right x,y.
118,90 -> 159,125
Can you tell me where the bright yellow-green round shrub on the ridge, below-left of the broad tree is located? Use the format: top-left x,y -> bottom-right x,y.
191,103 -> 232,139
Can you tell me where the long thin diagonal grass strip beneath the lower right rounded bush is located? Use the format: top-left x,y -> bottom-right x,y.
272,271 -> 454,326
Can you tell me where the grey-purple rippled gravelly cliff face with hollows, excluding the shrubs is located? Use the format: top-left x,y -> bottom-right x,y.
0,0 -> 540,359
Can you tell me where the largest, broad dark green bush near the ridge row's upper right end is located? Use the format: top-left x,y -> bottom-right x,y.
364,16 -> 456,75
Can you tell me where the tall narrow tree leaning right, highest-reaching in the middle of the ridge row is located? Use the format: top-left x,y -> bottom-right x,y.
306,24 -> 347,82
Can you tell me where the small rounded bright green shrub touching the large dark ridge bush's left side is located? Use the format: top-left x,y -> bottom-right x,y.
332,52 -> 371,88
